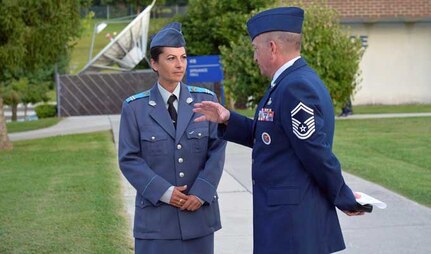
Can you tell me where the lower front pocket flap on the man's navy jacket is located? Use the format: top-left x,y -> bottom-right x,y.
267,186 -> 301,206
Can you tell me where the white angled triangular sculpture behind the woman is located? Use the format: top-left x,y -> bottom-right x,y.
79,0 -> 156,73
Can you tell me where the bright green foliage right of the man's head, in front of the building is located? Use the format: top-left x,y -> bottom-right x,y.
301,4 -> 363,108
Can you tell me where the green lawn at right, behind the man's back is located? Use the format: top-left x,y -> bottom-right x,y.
334,117 -> 431,207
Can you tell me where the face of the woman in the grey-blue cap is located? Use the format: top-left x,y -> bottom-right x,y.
151,47 -> 187,87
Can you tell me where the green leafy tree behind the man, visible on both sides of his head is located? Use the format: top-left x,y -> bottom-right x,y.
221,3 -> 362,108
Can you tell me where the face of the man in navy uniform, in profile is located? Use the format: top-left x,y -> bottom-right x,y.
251,34 -> 272,78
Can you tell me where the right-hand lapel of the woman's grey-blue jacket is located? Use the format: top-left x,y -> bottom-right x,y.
175,83 -> 194,143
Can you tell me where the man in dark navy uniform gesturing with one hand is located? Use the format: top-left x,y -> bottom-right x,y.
194,7 -> 363,254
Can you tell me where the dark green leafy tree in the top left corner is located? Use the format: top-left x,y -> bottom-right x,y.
0,0 -> 82,150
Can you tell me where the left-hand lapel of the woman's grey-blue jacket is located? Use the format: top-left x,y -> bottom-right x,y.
148,85 -> 175,139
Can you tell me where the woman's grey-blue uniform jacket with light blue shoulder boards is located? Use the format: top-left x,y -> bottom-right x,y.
118,84 -> 226,240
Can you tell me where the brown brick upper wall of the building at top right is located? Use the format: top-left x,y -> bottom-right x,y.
282,0 -> 431,21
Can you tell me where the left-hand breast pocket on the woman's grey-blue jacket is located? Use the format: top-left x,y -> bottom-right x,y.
141,132 -> 168,156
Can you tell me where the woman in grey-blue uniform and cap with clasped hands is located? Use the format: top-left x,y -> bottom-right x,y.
119,23 -> 226,254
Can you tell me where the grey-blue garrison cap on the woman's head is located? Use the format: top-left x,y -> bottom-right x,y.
150,22 -> 186,48
